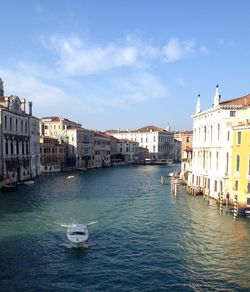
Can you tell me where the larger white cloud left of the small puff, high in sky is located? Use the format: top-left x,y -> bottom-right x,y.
47,37 -> 138,75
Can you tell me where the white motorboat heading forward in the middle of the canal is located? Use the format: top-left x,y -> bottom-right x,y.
67,224 -> 89,247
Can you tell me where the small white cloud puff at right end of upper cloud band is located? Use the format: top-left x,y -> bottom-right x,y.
162,38 -> 208,63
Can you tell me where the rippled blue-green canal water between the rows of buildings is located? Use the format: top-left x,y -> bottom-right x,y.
0,165 -> 250,291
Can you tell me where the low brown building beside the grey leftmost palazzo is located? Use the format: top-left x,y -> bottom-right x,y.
40,136 -> 66,173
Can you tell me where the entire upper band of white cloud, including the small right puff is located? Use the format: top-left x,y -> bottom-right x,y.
41,35 -> 208,76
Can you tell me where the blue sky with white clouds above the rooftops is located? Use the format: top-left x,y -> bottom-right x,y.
0,0 -> 250,131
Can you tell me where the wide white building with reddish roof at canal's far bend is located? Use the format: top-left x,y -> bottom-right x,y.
107,126 -> 174,161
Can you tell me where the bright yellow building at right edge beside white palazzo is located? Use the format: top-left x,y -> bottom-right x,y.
230,123 -> 250,207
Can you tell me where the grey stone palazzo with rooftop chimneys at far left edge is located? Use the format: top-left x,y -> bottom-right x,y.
0,79 -> 40,182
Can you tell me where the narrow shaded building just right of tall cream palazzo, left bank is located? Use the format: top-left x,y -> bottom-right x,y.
94,132 -> 111,168
